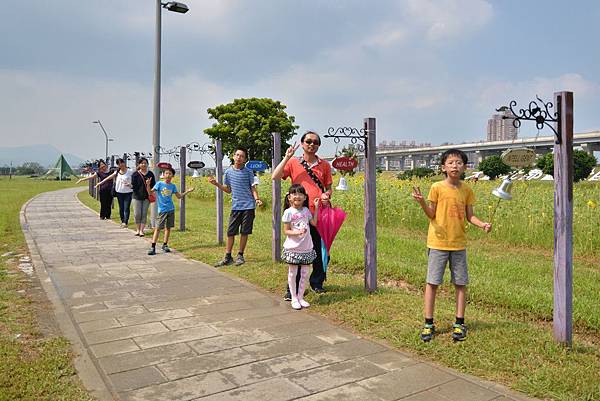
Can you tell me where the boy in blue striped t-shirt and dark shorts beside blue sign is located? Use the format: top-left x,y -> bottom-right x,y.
208,148 -> 262,267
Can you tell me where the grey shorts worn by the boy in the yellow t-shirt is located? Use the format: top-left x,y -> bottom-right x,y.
427,248 -> 469,285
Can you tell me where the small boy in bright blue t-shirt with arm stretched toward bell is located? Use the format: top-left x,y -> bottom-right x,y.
148,167 -> 194,255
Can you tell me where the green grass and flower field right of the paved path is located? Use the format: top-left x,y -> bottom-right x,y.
80,176 -> 600,400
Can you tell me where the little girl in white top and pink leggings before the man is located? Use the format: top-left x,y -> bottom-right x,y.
281,184 -> 321,310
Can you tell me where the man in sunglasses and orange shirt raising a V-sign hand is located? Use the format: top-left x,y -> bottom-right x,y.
272,131 -> 333,300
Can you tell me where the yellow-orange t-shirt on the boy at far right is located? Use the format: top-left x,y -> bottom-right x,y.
427,181 -> 475,251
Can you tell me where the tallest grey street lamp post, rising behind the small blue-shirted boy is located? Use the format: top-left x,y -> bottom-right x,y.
151,0 -> 189,227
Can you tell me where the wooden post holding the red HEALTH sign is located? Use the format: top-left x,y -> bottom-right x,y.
364,117 -> 377,292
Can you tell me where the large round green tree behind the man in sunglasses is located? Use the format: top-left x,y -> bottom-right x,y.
204,98 -> 298,164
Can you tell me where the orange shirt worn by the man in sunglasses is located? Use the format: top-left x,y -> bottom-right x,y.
281,156 -> 333,213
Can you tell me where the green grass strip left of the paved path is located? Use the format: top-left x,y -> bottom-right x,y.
0,177 -> 92,401
